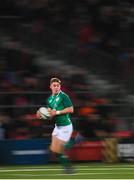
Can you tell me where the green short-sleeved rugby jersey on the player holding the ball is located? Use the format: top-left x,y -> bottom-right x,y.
47,91 -> 73,126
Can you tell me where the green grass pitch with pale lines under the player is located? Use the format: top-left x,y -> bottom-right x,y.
0,163 -> 134,179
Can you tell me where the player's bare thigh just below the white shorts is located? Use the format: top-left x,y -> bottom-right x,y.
50,136 -> 66,153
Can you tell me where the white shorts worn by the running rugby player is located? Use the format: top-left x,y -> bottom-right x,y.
52,124 -> 73,142
